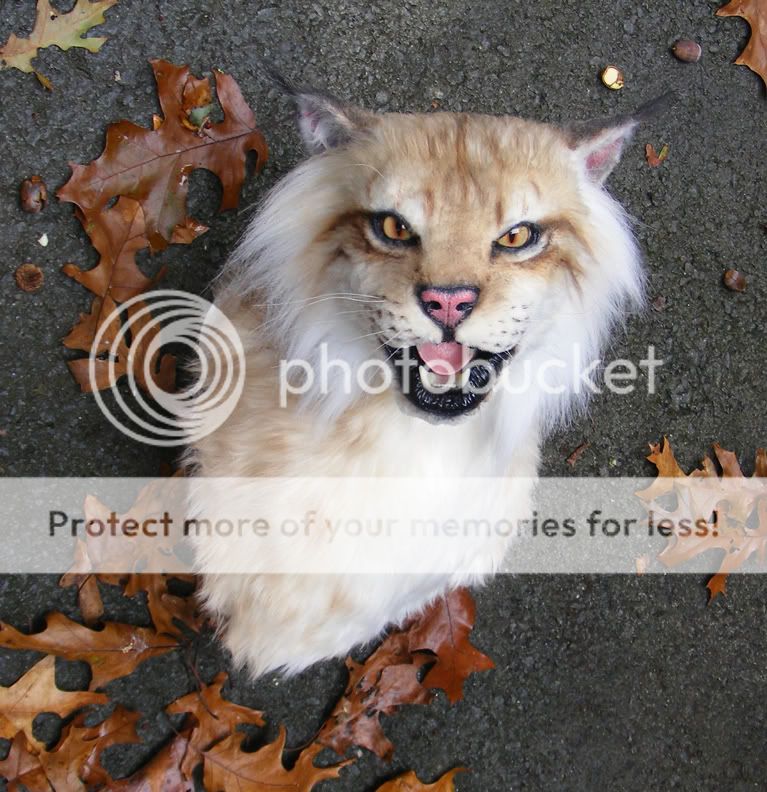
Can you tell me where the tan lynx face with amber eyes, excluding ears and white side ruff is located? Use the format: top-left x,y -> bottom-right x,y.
328,113 -> 600,418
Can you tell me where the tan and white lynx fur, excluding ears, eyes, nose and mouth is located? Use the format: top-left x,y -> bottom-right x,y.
190,102 -> 641,673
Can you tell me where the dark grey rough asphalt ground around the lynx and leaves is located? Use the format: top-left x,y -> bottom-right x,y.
0,0 -> 767,792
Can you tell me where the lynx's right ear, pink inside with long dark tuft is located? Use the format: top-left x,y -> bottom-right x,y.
568,93 -> 674,184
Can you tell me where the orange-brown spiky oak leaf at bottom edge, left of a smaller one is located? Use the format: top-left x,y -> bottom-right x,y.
203,726 -> 351,792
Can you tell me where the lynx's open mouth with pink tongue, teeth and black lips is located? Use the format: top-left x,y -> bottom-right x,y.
386,341 -> 514,418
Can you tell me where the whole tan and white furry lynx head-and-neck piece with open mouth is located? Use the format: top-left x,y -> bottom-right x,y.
189,76 -> 657,676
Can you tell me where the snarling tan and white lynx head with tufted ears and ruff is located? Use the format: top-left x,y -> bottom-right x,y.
230,76 -> 664,421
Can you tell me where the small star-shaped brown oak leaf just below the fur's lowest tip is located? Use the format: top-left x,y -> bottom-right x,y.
165,672 -> 265,780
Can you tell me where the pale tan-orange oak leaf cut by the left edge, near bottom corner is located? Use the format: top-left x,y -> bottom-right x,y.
0,655 -> 108,745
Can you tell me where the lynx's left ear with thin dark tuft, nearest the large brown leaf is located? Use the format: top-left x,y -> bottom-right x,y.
263,64 -> 373,154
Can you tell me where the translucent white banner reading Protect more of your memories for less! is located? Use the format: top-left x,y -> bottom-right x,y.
0,477 -> 767,576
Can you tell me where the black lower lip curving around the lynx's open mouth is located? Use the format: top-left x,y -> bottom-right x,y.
385,345 -> 515,418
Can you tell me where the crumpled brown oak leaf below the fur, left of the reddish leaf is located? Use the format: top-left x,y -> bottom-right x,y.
317,632 -> 433,762
